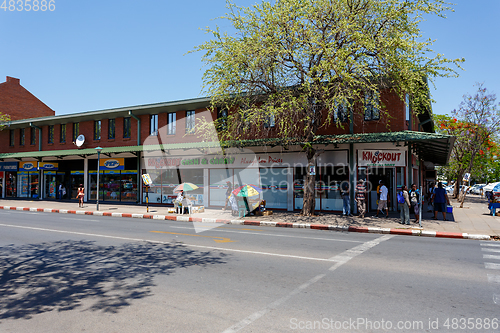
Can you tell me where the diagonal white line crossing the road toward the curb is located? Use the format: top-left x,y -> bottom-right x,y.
223,235 -> 394,333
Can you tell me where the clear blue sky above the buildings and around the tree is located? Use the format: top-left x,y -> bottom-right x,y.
0,0 -> 500,115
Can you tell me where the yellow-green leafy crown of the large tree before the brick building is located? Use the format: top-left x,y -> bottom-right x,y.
195,0 -> 463,141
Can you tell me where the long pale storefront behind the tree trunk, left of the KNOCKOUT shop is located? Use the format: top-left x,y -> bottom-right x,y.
142,150 -> 349,211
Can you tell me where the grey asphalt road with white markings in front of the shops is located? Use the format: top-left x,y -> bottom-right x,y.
0,211 -> 500,333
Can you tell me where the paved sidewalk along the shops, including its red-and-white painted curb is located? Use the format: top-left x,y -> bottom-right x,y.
0,195 -> 500,240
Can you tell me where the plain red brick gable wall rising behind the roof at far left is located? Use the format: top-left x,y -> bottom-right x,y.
0,76 -> 55,120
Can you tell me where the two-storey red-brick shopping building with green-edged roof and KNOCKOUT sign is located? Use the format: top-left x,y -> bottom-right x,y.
0,76 -> 454,211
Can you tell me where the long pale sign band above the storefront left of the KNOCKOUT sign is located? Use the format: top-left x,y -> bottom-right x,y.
145,150 -> 348,169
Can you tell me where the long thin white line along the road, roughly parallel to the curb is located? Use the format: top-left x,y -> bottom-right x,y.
0,224 -> 340,262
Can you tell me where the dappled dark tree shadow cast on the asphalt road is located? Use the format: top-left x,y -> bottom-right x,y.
0,240 -> 226,320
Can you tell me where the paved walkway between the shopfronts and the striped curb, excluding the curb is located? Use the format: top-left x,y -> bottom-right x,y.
0,195 -> 500,240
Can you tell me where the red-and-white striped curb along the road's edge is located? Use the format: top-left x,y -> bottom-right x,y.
0,206 -> 492,240
